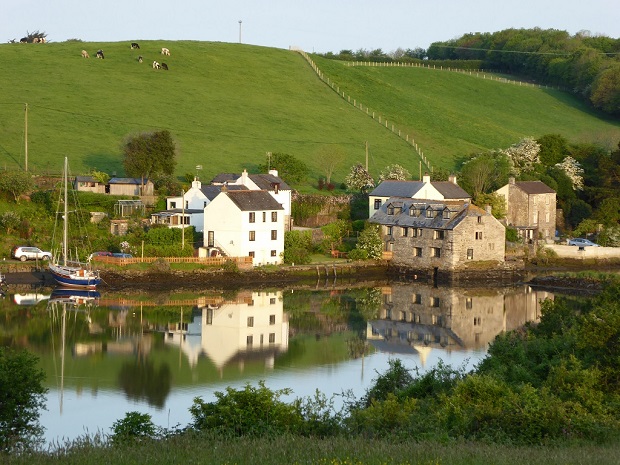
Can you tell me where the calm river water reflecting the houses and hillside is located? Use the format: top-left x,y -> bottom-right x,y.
0,284 -> 553,442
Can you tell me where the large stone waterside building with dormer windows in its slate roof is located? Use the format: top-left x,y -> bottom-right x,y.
369,197 -> 506,271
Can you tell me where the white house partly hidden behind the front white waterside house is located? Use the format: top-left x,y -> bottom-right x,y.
211,170 -> 292,231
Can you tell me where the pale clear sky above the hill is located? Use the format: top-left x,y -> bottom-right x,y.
0,0 -> 620,53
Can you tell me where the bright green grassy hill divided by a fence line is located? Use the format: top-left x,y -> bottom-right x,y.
0,41 -> 620,190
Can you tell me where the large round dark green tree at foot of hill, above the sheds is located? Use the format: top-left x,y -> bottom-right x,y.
123,130 -> 176,190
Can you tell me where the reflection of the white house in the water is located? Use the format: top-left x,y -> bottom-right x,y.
166,291 -> 289,373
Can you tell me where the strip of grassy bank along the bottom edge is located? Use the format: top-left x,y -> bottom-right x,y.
8,435 -> 620,465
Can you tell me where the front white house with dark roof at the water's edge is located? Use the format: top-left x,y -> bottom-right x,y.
203,186 -> 284,266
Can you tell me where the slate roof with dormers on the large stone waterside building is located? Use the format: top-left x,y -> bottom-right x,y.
369,197 -> 488,229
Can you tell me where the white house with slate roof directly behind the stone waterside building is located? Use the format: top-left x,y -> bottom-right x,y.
368,175 -> 471,218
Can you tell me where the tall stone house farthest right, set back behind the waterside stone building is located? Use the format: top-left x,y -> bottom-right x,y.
495,178 -> 556,242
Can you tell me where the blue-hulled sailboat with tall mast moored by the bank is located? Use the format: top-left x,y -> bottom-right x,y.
49,157 -> 101,289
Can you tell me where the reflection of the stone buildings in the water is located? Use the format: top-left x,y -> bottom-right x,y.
366,284 -> 553,365
